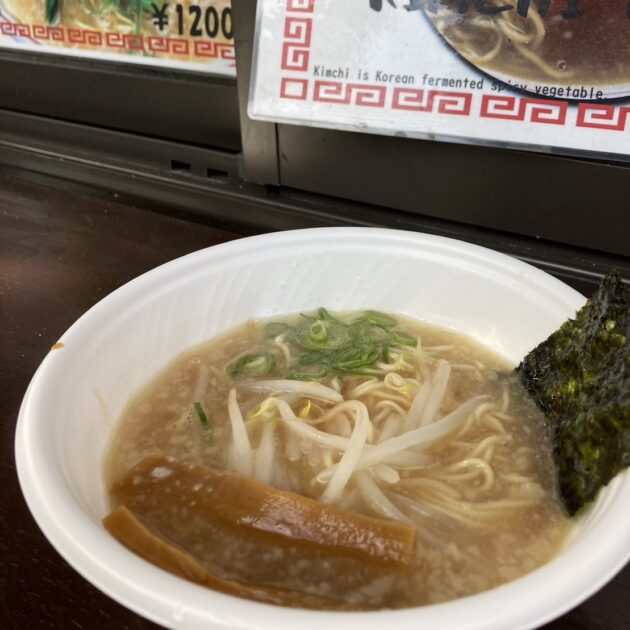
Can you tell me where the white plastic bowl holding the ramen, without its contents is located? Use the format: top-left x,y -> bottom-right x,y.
16,228 -> 630,630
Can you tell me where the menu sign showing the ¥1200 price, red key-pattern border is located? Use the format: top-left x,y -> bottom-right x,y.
0,0 -> 236,76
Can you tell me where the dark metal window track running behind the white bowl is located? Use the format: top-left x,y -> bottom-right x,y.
0,110 -> 630,294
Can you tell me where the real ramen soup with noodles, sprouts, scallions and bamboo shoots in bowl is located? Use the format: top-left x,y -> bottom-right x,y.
105,309 -> 569,610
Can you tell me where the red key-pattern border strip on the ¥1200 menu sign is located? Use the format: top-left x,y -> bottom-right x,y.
0,22 -> 235,60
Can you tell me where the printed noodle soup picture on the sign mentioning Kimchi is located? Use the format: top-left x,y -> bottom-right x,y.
423,0 -> 630,87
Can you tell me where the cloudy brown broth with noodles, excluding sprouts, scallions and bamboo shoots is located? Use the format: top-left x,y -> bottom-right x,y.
106,314 -> 569,608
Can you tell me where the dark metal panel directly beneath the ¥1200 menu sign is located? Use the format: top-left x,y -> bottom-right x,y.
0,50 -> 241,151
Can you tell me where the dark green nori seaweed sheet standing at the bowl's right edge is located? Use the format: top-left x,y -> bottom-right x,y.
517,272 -> 630,515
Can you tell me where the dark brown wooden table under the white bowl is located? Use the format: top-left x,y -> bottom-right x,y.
0,170 -> 630,630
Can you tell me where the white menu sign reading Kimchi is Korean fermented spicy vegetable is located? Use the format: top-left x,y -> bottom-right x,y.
249,0 -> 630,156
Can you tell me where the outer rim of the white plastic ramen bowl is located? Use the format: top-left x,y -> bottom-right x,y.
15,227 -> 630,630
